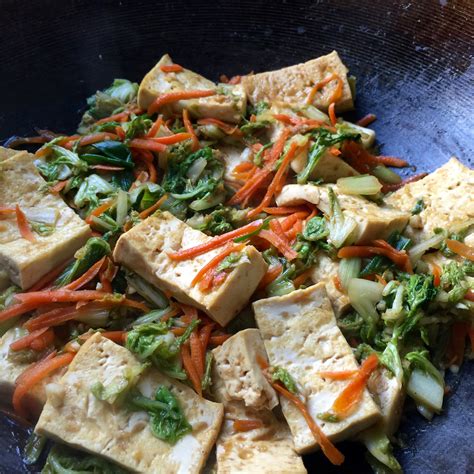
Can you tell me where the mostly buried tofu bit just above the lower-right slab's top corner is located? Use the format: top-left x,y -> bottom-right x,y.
311,252 -> 351,318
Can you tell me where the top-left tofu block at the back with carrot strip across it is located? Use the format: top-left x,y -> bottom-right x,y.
138,54 -> 247,123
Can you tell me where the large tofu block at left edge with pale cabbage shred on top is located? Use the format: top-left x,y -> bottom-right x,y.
0,152 -> 91,289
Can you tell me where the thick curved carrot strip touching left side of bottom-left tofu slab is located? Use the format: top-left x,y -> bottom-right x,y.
12,352 -> 74,418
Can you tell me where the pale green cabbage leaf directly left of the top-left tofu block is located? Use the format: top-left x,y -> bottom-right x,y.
78,79 -> 138,134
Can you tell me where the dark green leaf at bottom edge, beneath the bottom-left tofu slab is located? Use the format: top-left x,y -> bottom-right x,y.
41,444 -> 127,474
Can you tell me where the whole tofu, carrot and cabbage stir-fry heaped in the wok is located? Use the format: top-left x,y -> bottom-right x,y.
0,51 -> 474,474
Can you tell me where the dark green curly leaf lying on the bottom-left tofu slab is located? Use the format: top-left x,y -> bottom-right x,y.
128,385 -> 192,444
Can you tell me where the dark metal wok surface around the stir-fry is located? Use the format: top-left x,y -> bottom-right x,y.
0,0 -> 474,473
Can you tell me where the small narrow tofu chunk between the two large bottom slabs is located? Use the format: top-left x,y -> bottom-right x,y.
213,329 -> 278,410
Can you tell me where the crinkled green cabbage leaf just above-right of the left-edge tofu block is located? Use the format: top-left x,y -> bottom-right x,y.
36,145 -> 88,183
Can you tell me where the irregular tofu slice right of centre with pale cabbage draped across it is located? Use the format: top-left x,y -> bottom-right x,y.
276,184 -> 410,244
